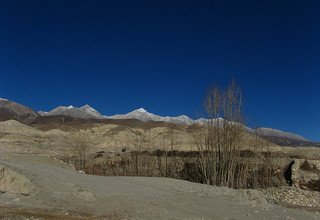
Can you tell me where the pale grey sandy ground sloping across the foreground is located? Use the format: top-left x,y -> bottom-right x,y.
0,152 -> 320,220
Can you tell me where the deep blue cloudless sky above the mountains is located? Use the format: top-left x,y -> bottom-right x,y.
0,0 -> 320,141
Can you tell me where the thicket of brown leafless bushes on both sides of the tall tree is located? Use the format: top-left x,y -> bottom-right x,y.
67,150 -> 286,188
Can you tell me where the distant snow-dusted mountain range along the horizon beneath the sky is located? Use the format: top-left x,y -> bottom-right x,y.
0,98 -> 315,146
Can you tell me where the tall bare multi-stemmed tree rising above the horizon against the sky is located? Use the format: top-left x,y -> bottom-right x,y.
193,81 -> 244,188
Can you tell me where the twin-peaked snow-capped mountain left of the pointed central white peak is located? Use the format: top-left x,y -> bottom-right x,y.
39,105 -> 102,119
